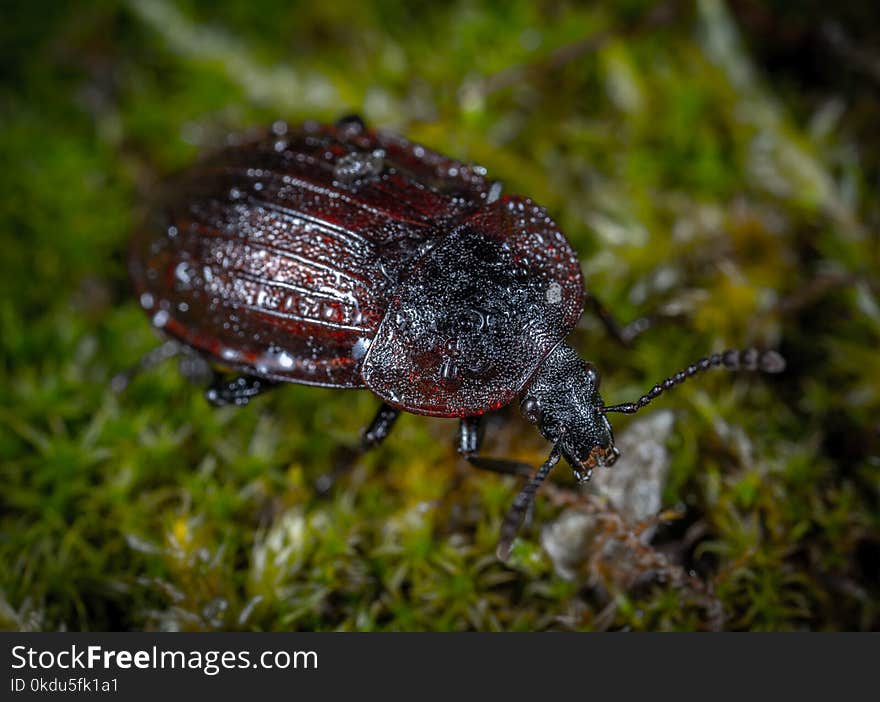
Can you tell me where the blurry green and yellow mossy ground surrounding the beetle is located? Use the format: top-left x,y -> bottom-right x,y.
0,0 -> 880,630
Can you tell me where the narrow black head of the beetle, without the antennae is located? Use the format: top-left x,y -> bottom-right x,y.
520,343 -> 620,480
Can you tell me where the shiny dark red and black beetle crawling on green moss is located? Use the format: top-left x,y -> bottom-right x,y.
129,116 -> 785,559
